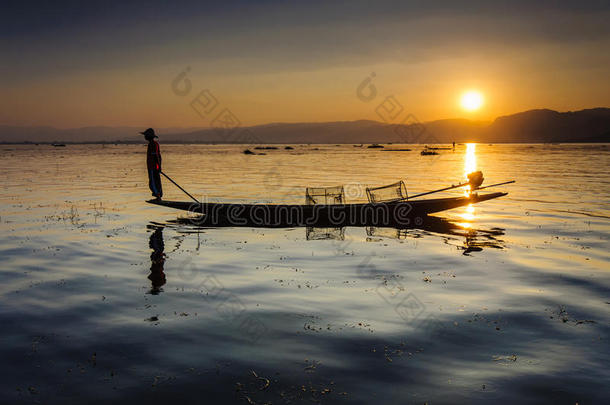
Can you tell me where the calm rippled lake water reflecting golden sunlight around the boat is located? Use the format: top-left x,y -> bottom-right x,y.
0,144 -> 610,404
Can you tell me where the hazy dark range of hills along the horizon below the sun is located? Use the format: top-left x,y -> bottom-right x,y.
0,108 -> 610,144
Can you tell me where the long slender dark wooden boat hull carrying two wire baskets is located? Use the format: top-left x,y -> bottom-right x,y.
147,192 -> 508,228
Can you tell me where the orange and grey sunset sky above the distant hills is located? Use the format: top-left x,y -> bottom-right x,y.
0,2 -> 610,128
